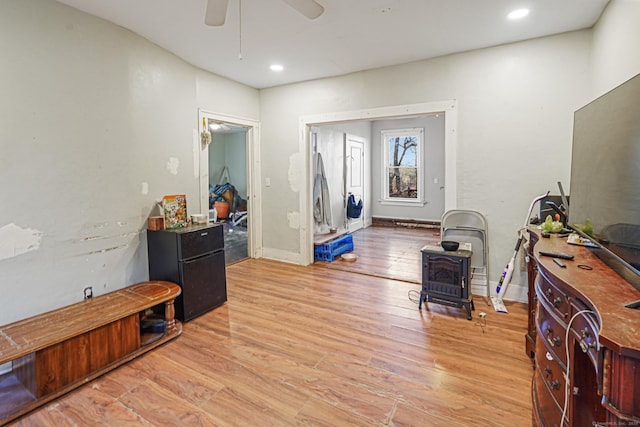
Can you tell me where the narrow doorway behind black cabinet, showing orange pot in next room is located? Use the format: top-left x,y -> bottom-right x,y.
199,110 -> 262,264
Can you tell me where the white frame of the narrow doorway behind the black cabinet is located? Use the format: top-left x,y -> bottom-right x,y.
198,108 -> 262,258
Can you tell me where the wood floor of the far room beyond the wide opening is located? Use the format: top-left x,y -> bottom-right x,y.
316,226 -> 440,283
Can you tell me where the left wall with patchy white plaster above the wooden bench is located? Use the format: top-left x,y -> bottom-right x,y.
0,0 -> 259,324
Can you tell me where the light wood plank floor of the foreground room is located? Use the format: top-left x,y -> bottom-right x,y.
14,260 -> 532,427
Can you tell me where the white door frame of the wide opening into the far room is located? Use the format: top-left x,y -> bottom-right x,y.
298,99 -> 458,265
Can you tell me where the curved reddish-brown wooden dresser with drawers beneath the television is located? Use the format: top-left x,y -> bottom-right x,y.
526,230 -> 640,427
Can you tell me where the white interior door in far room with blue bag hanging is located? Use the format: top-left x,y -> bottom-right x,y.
344,134 -> 365,232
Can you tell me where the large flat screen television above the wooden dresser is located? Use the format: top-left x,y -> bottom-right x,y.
569,74 -> 640,290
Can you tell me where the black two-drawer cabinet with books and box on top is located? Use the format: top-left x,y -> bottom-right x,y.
147,224 -> 227,322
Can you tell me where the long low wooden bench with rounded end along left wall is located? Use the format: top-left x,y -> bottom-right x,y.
0,281 -> 182,425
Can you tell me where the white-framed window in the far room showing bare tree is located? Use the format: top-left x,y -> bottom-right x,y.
381,128 -> 424,203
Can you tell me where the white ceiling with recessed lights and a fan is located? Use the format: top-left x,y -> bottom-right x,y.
58,0 -> 609,88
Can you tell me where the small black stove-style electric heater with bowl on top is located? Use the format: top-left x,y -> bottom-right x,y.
418,246 -> 475,320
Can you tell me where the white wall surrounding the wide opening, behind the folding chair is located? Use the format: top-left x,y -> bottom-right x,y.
260,31 -> 591,299
